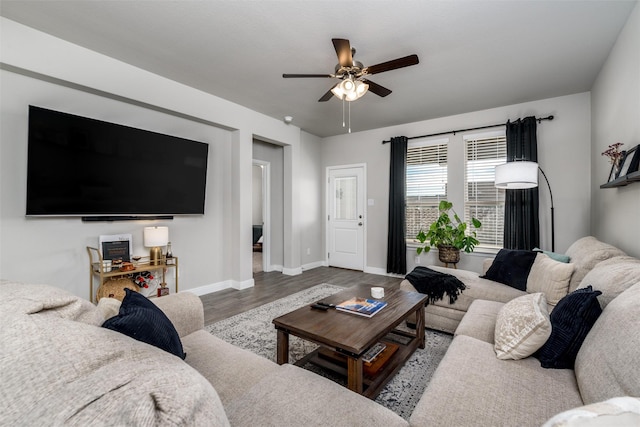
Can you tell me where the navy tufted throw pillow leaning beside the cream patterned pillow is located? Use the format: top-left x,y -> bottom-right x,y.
535,285 -> 602,369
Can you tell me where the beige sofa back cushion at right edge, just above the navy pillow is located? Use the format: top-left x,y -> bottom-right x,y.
578,256 -> 640,309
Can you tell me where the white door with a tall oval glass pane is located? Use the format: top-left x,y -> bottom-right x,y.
327,166 -> 365,271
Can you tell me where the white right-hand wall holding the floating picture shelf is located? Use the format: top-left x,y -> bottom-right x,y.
591,5 -> 640,257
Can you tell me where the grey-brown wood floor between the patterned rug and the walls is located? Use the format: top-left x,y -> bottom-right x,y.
200,267 -> 402,325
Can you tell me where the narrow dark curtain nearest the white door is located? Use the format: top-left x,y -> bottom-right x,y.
387,136 -> 408,274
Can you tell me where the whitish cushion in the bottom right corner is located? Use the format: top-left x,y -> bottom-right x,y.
542,396 -> 640,427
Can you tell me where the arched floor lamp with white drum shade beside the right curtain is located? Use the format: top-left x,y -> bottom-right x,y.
495,161 -> 556,252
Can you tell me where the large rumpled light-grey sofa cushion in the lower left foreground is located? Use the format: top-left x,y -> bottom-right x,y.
0,300 -> 229,426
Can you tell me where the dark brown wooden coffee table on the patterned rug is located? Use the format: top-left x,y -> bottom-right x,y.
273,285 -> 428,399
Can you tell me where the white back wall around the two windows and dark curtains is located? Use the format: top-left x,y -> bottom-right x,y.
322,93 -> 591,273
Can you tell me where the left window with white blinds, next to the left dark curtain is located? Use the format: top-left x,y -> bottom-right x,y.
405,138 -> 449,240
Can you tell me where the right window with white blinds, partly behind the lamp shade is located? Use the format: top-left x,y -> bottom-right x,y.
464,132 -> 507,248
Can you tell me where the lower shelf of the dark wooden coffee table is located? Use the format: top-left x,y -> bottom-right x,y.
295,330 -> 417,399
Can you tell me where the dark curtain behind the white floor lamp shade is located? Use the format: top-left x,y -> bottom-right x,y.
504,117 -> 540,250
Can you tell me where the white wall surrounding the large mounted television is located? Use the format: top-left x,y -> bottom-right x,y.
0,18 -> 310,297
